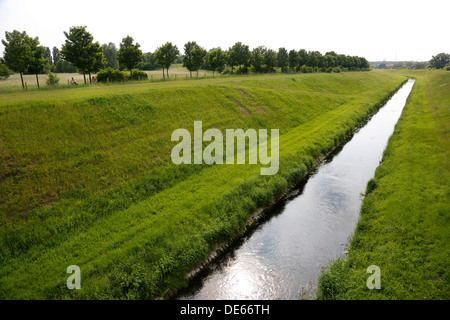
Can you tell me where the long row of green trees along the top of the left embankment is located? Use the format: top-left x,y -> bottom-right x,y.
1,26 -> 370,87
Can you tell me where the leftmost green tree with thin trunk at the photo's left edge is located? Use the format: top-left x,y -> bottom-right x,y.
2,30 -> 32,89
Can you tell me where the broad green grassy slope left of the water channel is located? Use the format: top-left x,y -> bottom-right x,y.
0,72 -> 405,299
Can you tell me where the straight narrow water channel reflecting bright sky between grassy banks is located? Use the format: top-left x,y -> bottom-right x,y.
179,80 -> 414,300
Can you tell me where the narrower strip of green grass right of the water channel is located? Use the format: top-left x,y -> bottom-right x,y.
318,71 -> 450,299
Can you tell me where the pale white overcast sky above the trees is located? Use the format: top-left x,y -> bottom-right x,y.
0,0 -> 450,61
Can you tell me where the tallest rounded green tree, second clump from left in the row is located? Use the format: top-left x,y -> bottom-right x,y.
61,26 -> 103,84
